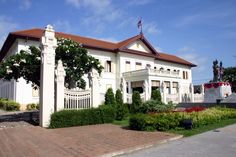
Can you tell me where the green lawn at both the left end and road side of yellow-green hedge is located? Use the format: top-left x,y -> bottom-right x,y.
113,117 -> 236,137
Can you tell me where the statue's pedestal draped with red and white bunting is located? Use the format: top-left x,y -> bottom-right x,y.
204,82 -> 232,103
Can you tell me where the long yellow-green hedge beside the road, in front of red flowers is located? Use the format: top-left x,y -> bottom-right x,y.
129,108 -> 236,131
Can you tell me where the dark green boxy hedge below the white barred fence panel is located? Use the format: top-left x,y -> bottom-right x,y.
49,105 -> 115,128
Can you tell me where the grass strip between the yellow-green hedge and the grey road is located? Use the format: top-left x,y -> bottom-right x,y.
167,118 -> 236,137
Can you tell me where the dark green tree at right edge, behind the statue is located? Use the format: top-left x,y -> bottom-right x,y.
223,67 -> 236,92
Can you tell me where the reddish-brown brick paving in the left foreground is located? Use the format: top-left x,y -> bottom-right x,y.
0,124 -> 181,157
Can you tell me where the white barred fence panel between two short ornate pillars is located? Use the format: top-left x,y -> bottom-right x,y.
64,90 -> 92,109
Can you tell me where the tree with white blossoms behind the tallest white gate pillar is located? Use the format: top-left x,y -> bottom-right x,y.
0,38 -> 103,89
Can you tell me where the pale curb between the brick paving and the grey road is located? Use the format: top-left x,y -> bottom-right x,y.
100,135 -> 183,157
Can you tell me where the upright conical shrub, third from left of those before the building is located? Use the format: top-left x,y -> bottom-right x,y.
130,91 -> 142,113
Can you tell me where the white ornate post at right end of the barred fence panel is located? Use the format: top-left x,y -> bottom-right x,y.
88,69 -> 101,107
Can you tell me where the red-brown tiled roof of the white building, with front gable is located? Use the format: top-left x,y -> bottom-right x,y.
0,28 -> 196,67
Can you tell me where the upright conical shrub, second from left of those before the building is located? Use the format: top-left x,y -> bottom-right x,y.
115,89 -> 128,120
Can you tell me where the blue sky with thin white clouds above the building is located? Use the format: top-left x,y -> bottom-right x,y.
0,0 -> 236,84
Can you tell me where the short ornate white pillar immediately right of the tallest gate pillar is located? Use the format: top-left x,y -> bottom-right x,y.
55,60 -> 66,111
